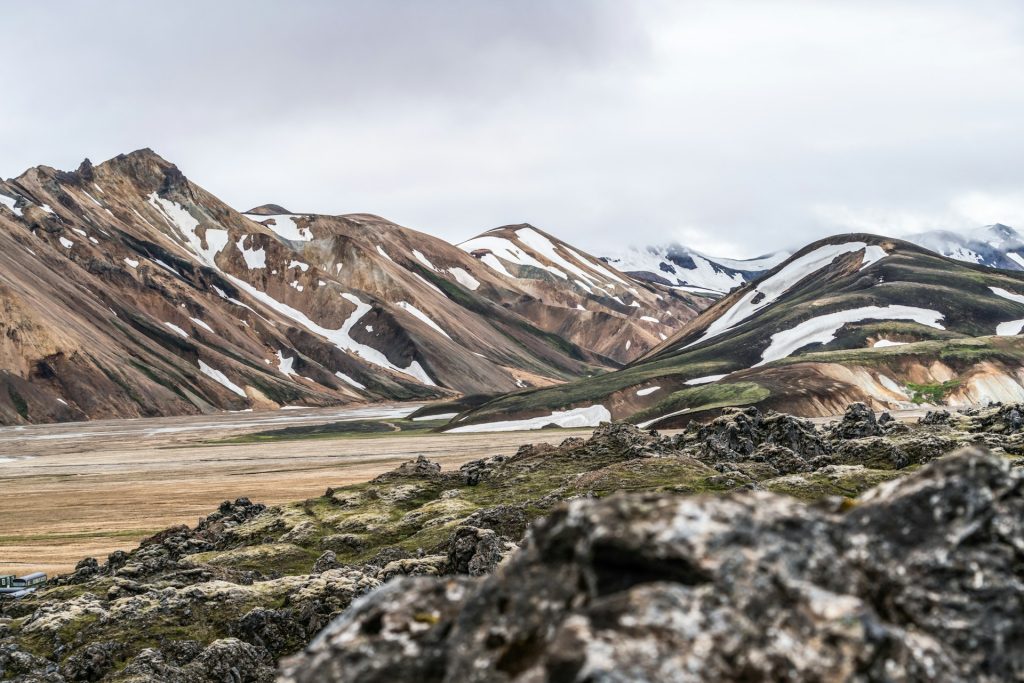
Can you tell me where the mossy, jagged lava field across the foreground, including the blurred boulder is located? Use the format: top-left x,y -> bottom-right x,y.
0,405 -> 1024,683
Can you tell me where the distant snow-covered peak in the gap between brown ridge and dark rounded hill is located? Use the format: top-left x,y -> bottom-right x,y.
605,245 -> 792,295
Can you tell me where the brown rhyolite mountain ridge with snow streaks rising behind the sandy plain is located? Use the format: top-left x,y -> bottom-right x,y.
0,150 -> 708,424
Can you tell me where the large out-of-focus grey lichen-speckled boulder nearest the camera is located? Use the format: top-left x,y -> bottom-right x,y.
280,448 -> 1024,683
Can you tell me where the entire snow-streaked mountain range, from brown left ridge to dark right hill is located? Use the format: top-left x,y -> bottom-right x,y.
6,150 -> 1024,431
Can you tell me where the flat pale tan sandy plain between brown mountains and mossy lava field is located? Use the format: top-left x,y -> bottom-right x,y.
0,405 -> 592,574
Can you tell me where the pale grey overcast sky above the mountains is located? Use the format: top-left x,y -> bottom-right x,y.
6,0 -> 1024,256
